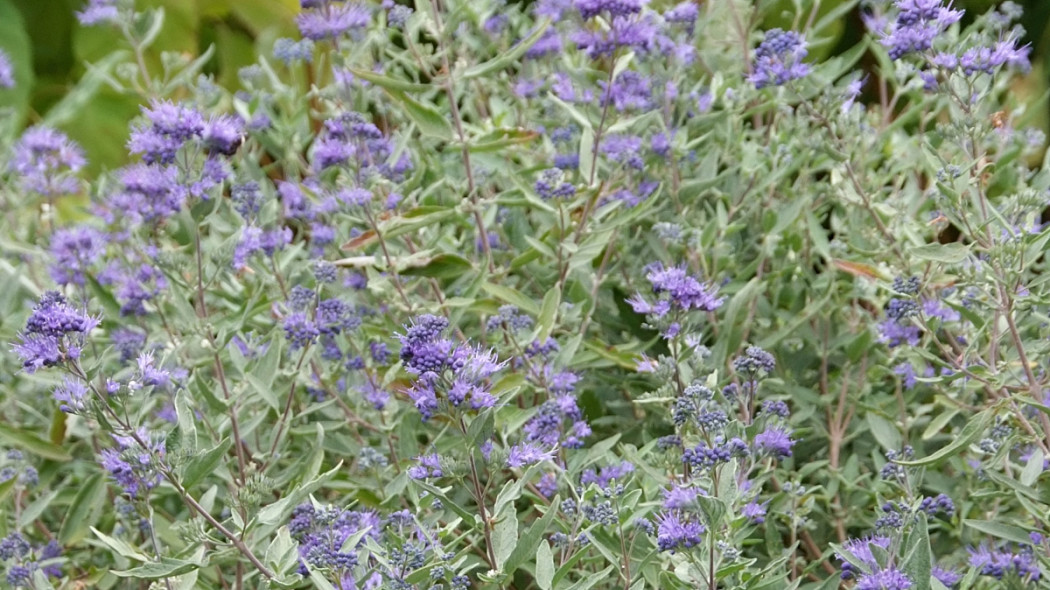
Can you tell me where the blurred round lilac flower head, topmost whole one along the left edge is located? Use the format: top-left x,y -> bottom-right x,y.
8,126 -> 87,196
